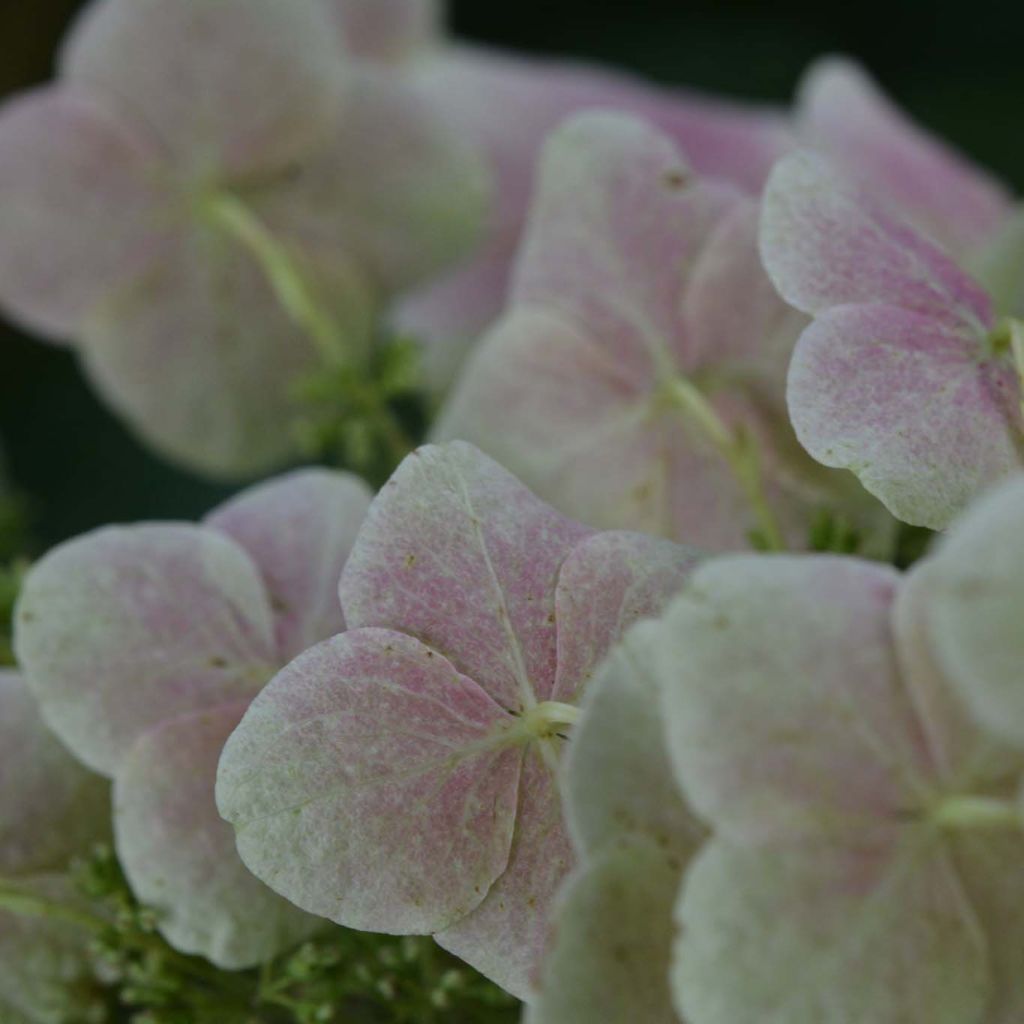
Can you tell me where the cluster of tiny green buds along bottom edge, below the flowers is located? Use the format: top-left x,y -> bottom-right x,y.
64,847 -> 519,1024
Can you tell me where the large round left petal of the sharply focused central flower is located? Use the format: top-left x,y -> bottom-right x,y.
217,630 -> 523,934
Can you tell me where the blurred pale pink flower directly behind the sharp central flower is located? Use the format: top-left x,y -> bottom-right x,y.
436,113 -> 888,548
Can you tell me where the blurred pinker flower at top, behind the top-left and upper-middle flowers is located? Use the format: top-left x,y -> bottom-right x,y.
352,0 -> 792,389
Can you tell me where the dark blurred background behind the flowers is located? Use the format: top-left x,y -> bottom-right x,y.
0,0 -> 1024,547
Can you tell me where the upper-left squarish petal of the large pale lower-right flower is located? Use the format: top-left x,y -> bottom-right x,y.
652,556 -> 935,840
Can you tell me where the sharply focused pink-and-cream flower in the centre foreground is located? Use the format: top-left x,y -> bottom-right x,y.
217,443 -> 694,997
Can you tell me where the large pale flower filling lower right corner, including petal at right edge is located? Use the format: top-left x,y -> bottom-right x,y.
648,479 -> 1024,1024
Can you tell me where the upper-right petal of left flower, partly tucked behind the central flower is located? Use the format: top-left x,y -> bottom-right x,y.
205,469 -> 373,664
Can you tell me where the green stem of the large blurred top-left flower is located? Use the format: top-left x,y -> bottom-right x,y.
204,193 -> 415,465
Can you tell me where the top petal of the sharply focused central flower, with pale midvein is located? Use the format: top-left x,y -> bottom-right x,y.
341,442 -> 590,711
